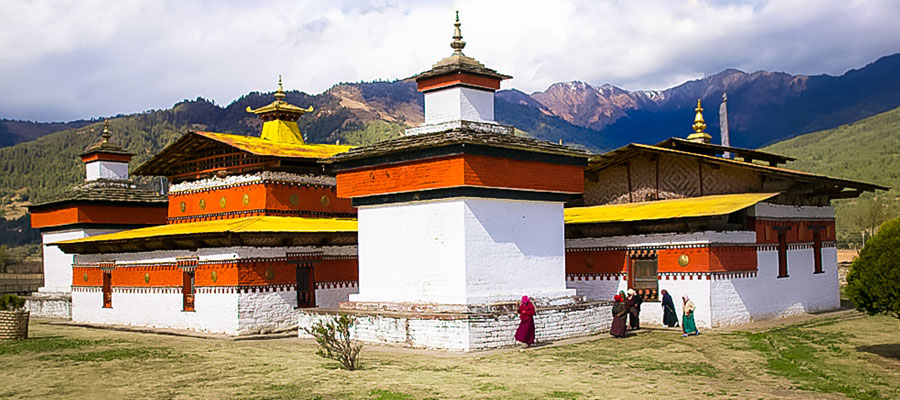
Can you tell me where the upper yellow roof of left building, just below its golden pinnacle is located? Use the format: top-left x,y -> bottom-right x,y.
194,132 -> 353,158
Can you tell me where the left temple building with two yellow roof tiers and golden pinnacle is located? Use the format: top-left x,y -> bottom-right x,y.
53,79 -> 357,335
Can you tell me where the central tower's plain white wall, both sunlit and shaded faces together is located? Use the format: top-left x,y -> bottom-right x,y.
350,199 -> 575,304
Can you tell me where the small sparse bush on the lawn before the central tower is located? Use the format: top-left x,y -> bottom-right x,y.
303,314 -> 362,371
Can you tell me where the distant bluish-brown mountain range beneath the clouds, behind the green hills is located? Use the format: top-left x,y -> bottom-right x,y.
0,54 -> 900,151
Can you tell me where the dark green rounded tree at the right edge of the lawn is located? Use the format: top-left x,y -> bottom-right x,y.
847,217 -> 900,322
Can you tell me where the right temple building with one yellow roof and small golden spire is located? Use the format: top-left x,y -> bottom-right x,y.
566,100 -> 887,327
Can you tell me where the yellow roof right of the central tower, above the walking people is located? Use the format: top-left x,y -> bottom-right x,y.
564,193 -> 778,224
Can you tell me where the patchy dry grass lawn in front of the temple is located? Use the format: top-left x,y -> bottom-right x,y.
0,312 -> 900,400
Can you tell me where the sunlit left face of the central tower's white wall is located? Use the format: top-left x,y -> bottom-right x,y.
350,200 -> 465,304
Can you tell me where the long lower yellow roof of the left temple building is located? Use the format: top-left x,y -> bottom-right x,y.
54,216 -> 356,244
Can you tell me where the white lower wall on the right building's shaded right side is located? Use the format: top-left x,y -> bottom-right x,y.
711,247 -> 840,326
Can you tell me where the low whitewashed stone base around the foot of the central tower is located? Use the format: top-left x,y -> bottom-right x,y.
298,299 -> 612,351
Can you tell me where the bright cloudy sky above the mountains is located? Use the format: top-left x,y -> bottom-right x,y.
0,0 -> 900,121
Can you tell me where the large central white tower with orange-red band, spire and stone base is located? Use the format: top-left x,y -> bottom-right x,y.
298,11 -> 611,351
